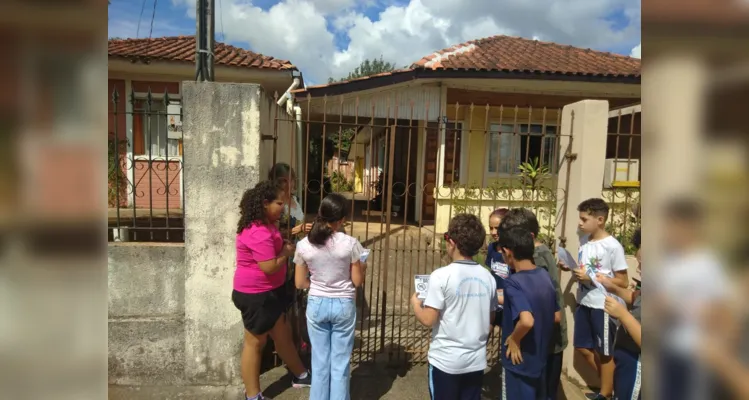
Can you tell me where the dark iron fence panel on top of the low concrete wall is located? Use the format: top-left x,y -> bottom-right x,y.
107,87 -> 185,242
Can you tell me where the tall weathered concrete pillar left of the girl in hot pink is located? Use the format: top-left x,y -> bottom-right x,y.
182,82 -> 264,385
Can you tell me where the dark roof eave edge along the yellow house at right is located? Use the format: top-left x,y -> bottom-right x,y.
294,68 -> 641,99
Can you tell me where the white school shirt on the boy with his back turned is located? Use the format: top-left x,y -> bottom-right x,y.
424,260 -> 498,375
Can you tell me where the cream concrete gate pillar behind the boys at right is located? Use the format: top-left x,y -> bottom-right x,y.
556,100 -> 609,386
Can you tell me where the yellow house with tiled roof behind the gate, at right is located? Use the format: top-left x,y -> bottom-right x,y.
292,36 -> 641,232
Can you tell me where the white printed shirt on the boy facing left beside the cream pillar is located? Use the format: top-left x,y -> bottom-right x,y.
577,235 -> 629,310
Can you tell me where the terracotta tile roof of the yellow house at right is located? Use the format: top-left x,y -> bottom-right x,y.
411,36 -> 640,77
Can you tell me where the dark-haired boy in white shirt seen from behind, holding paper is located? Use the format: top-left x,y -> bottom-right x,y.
411,214 -> 498,400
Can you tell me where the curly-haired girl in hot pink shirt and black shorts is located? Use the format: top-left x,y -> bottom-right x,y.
232,181 -> 311,400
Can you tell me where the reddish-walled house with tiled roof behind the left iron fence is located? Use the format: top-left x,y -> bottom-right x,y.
107,36 -> 303,219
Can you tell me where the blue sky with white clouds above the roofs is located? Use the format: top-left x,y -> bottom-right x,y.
109,0 -> 640,83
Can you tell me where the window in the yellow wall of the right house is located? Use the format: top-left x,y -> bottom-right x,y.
486,124 -> 557,175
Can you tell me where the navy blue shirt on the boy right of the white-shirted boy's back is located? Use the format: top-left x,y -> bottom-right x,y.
500,268 -> 559,378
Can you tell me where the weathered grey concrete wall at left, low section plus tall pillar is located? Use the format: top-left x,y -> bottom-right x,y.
109,82 -> 266,398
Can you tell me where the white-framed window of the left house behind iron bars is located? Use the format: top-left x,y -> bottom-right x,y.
133,99 -> 182,157
